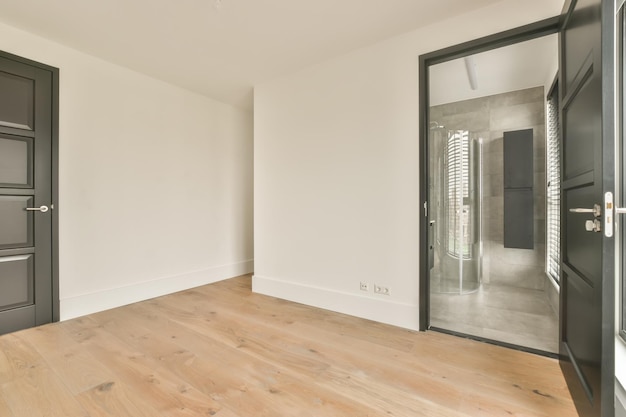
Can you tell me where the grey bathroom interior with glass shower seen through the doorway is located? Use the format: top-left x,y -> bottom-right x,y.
428,36 -> 559,355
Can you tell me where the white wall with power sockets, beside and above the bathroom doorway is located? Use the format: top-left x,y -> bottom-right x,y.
253,0 -> 563,329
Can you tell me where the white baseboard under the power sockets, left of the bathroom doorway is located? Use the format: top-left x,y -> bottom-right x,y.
252,275 -> 419,330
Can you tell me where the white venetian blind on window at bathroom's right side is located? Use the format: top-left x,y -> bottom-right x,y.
546,87 -> 561,283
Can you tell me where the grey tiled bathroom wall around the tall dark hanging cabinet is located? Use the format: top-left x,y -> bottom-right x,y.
430,87 -> 546,289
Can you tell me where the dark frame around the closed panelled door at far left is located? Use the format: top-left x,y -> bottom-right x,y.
0,51 -> 60,321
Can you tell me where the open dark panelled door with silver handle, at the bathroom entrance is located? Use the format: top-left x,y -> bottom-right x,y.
560,0 -> 614,417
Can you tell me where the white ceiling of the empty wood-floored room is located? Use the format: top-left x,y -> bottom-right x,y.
0,0 -> 508,108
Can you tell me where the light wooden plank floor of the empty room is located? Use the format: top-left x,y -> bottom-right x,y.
0,276 -> 576,417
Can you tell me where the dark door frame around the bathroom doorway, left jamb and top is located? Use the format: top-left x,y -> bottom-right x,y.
419,16 -> 561,331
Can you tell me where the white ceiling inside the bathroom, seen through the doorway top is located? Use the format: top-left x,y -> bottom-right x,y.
429,35 -> 558,106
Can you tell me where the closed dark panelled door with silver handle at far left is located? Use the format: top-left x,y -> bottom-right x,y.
0,55 -> 58,334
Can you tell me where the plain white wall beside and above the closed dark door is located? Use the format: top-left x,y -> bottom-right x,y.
0,25 -> 253,319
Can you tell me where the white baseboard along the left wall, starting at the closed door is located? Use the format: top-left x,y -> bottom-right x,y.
60,260 -> 254,320
